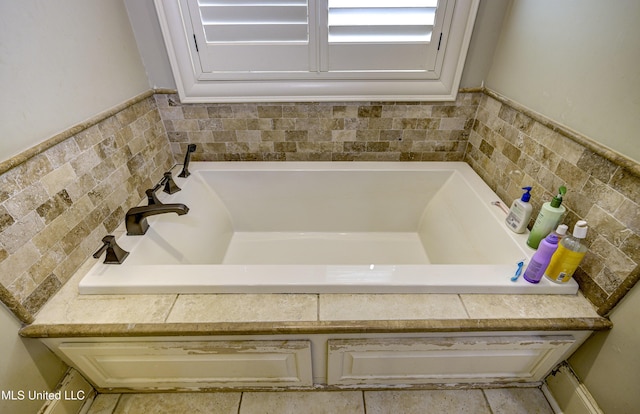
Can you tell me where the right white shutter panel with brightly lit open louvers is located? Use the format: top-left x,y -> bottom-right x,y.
322,0 -> 455,74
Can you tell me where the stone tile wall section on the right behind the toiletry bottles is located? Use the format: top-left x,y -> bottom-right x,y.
465,92 -> 640,314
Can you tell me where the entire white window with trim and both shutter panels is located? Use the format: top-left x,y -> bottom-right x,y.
154,0 -> 480,102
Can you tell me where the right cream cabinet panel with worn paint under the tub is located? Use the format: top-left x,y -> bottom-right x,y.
328,335 -> 575,385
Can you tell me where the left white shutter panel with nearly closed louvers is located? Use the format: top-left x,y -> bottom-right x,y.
187,0 -> 316,73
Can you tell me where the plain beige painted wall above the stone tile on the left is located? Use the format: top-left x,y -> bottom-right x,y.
0,0 -> 149,161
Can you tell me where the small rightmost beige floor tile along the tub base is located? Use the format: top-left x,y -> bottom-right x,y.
484,388 -> 553,414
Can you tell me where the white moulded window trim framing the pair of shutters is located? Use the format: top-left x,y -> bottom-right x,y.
155,0 -> 479,103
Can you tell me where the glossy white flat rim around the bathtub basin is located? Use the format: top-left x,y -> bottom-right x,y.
79,161 -> 578,295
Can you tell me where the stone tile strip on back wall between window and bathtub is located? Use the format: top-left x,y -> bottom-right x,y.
156,93 -> 482,161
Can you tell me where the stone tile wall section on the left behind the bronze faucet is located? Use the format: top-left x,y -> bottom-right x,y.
0,93 -> 174,322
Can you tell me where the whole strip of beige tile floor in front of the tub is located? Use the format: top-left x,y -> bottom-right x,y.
88,388 -> 553,414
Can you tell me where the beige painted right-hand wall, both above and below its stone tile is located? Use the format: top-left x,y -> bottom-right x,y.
486,0 -> 640,413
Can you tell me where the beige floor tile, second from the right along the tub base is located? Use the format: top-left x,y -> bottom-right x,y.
364,390 -> 491,414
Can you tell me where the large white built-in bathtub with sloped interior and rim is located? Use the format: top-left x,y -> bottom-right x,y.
80,162 -> 578,294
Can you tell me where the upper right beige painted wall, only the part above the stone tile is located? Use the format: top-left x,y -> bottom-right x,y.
486,0 -> 640,161
